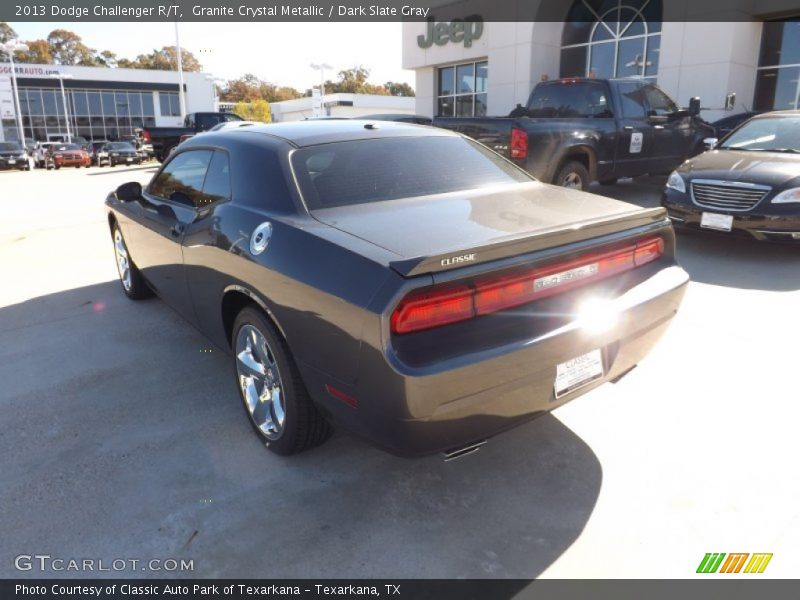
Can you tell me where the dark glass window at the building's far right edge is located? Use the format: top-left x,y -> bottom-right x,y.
753,20 -> 800,111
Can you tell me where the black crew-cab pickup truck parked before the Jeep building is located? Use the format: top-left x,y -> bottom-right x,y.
433,78 -> 714,190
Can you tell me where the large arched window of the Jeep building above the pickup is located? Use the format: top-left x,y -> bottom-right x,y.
560,0 -> 662,79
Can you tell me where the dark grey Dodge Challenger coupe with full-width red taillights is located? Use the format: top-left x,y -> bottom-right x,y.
106,120 -> 688,456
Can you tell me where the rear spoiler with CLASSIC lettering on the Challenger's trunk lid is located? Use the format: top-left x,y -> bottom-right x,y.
389,207 -> 669,277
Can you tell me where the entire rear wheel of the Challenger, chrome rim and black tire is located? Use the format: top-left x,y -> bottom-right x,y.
231,307 -> 332,456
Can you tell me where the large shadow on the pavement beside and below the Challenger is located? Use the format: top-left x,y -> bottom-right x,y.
0,281 -> 602,578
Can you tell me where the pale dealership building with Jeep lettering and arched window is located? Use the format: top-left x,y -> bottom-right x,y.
403,0 -> 800,120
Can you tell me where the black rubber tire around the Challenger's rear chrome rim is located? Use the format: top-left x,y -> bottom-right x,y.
231,306 -> 333,456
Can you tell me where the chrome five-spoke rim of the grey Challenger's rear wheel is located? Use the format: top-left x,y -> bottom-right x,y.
235,325 -> 286,440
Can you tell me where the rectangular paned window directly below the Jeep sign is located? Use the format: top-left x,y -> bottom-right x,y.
436,61 -> 489,117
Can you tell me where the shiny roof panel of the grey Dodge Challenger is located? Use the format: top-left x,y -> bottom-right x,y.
203,119 -> 458,147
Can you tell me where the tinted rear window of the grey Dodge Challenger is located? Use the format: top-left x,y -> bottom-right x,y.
292,137 -> 532,210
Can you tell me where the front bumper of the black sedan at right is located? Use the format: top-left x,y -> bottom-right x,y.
661,190 -> 800,242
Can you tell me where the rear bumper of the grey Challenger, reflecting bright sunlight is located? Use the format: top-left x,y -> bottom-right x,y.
301,266 -> 689,456
